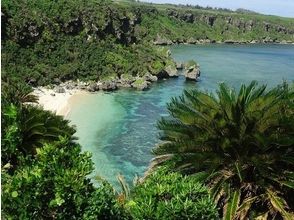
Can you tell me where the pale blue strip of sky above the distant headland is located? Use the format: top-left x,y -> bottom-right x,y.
141,0 -> 294,18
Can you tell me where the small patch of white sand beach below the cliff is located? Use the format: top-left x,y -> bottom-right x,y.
33,87 -> 85,116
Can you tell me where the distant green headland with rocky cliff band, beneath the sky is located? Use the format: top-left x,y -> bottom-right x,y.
117,1 -> 294,43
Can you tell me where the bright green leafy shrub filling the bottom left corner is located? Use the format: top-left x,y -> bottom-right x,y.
2,139 -> 129,219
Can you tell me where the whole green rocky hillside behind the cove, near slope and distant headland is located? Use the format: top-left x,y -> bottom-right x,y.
1,0 -> 294,85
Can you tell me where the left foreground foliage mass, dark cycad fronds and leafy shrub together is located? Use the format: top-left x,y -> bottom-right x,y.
1,87 -> 128,219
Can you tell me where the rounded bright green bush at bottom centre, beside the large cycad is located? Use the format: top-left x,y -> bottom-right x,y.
126,168 -> 218,220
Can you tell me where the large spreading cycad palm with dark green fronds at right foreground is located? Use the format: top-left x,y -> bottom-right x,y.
154,82 -> 294,219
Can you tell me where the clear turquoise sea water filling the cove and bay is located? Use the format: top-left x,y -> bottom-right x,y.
68,45 -> 294,185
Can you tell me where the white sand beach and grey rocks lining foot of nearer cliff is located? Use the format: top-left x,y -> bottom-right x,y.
33,61 -> 200,116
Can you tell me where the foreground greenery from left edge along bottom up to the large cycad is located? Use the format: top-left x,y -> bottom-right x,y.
1,84 -> 217,220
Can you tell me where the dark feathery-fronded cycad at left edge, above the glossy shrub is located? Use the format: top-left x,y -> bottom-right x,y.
1,83 -> 75,165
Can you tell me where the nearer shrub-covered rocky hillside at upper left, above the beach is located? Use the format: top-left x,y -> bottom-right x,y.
2,0 -> 171,86
